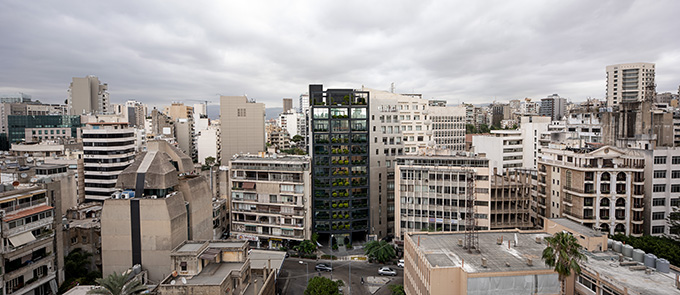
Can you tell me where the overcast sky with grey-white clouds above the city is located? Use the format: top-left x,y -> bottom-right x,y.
0,0 -> 680,107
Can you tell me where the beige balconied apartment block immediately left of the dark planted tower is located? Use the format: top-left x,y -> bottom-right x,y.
229,155 -> 314,249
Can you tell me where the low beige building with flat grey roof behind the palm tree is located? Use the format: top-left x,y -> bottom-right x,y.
404,219 -> 612,295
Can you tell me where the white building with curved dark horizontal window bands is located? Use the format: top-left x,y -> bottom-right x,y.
82,122 -> 135,201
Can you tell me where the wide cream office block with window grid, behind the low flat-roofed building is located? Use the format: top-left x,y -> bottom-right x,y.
395,155 -> 491,239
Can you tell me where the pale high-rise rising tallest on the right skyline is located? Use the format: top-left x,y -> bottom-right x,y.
607,62 -> 656,107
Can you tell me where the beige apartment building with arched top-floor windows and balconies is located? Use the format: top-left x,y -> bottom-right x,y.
537,146 -> 645,236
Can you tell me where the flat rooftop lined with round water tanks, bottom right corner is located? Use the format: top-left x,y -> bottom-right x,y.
582,251 -> 680,295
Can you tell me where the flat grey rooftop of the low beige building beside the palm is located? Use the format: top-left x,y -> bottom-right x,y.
410,232 -> 550,273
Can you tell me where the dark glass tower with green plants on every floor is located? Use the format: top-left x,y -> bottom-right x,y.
309,85 -> 370,245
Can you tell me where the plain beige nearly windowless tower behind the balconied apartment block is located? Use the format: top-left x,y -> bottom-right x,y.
220,96 -> 265,166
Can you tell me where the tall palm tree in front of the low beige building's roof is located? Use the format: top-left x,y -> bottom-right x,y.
542,232 -> 587,294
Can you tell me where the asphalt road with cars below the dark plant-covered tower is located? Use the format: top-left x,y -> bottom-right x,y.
277,257 -> 404,295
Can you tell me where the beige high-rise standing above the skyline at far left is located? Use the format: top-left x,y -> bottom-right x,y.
67,76 -> 112,115
